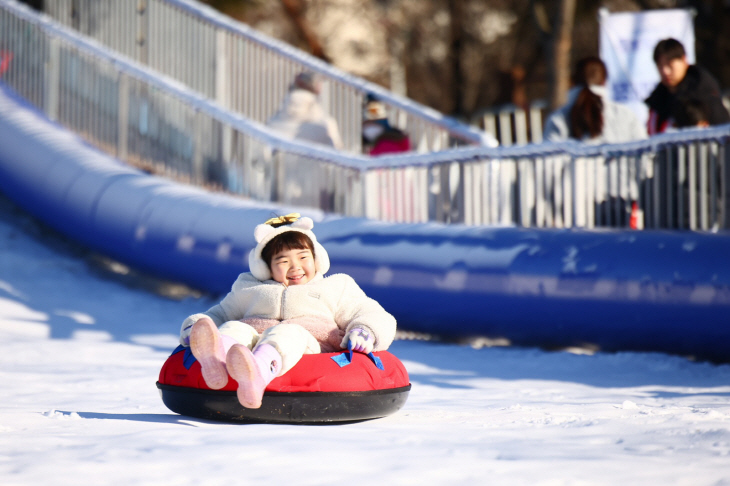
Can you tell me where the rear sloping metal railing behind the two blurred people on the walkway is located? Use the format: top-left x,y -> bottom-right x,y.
44,0 -> 492,153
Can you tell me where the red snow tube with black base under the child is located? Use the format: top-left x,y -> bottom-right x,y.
157,346 -> 411,423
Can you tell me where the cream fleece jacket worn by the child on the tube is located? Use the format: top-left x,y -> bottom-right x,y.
182,272 -> 396,352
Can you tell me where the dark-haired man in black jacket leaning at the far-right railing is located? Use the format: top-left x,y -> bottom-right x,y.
645,38 -> 730,135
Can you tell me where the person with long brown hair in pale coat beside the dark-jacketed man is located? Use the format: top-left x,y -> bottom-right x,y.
543,56 -> 647,144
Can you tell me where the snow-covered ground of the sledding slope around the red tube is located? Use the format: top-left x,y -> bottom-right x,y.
0,195 -> 730,486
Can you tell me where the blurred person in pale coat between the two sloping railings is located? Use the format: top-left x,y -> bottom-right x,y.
266,72 -> 342,150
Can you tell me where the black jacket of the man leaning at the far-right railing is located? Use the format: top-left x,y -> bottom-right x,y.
644,65 -> 730,133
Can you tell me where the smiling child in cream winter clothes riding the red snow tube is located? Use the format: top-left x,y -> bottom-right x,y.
180,213 -> 396,408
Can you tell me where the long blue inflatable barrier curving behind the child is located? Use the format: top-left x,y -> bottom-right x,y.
0,84 -> 730,361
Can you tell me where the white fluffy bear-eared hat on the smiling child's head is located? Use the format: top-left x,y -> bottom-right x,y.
248,213 -> 330,281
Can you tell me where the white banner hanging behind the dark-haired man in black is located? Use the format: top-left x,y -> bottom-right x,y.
599,9 -> 695,124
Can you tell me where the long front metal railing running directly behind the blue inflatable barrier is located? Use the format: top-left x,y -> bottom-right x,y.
0,0 -> 730,230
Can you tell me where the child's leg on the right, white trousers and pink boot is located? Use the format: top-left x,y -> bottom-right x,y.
226,324 -> 319,408
